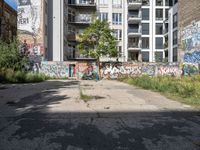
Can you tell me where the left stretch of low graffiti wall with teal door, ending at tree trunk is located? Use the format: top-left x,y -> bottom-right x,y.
38,61 -> 99,80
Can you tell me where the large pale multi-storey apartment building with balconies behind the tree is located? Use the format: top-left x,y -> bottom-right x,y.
48,0 -> 181,62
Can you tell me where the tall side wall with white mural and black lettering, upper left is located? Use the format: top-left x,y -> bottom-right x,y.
18,0 -> 45,56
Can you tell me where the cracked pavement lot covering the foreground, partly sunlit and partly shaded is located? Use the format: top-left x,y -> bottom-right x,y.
0,81 -> 200,150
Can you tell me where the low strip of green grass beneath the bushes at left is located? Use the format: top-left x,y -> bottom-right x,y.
0,69 -> 49,83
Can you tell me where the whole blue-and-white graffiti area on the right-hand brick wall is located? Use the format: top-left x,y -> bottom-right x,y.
181,21 -> 200,64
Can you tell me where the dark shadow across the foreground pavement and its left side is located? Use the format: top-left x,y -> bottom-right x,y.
0,81 -> 200,150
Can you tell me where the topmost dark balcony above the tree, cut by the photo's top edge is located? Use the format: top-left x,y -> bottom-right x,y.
68,0 -> 96,9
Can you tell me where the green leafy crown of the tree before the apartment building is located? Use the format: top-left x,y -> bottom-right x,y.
77,20 -> 118,59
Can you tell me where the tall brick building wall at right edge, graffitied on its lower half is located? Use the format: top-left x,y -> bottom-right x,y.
178,0 -> 200,64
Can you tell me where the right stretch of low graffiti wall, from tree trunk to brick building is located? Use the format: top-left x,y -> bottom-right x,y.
100,63 -> 182,79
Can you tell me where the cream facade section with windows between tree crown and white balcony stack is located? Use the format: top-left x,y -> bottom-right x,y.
97,0 -> 126,61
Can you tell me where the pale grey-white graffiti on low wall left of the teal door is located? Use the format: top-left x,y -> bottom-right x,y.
40,62 -> 69,78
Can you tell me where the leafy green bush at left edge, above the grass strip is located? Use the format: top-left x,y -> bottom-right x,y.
0,41 -> 27,71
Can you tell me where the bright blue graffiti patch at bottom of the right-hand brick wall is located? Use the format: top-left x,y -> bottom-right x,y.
184,51 -> 200,64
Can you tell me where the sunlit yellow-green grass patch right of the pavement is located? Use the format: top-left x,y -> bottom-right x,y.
119,75 -> 200,107
